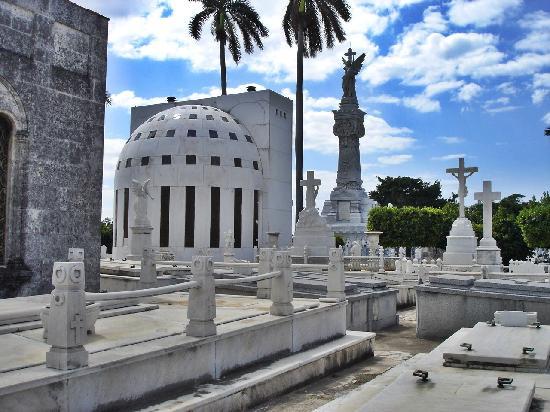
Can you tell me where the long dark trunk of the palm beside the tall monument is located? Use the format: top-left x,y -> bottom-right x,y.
294,22 -> 304,222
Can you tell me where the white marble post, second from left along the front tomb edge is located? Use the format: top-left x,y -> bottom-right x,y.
185,256 -> 216,337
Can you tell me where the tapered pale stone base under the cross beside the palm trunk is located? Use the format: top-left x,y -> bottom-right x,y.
292,208 -> 336,256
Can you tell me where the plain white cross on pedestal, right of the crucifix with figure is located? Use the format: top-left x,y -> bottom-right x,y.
474,180 -> 502,272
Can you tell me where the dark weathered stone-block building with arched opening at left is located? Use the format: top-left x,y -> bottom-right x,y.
0,0 -> 108,297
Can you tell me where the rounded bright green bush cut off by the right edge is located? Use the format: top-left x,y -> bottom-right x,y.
517,202 -> 550,249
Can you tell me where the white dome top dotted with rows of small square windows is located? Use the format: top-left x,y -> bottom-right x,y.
115,105 -> 262,189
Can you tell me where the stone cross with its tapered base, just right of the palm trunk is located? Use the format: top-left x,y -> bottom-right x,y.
292,170 -> 336,256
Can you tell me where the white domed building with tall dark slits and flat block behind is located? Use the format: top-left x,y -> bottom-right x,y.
113,90 -> 292,259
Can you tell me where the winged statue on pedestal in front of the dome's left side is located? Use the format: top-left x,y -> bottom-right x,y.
127,179 -> 153,260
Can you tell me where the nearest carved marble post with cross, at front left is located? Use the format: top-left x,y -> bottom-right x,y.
46,262 -> 88,370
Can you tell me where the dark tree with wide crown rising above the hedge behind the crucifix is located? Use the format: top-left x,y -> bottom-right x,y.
369,176 -> 446,207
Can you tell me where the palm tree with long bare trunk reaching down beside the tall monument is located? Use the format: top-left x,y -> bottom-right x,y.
283,0 -> 351,221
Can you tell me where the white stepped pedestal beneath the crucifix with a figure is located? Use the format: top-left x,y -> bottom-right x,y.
443,217 -> 477,265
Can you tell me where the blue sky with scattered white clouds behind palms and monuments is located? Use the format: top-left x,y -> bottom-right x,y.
76,0 -> 550,216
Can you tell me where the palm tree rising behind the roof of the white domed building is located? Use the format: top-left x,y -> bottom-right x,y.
189,0 -> 269,94
